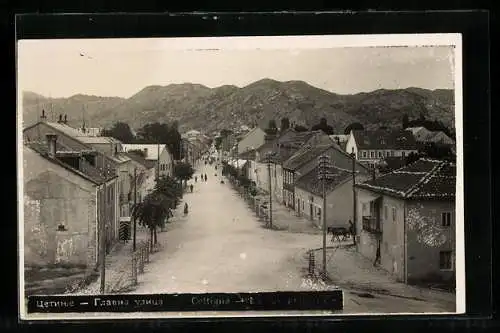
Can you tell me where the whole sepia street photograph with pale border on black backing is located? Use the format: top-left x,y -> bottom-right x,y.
17,34 -> 465,320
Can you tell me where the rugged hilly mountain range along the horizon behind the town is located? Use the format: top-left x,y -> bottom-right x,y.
23,79 -> 454,133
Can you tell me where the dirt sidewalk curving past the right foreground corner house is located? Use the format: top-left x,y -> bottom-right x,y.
314,246 -> 456,305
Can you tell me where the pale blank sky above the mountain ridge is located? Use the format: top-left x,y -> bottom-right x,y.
18,38 -> 454,97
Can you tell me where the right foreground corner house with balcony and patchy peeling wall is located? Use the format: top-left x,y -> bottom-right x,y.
356,158 -> 457,283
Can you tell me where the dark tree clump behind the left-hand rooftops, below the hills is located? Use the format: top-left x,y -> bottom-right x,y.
101,121 -> 184,160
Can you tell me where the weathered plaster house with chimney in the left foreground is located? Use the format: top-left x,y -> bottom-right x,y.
21,135 -> 118,272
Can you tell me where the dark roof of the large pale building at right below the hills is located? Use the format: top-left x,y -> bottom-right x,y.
353,130 -> 417,150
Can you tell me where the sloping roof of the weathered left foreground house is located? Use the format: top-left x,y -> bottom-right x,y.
26,142 -> 117,185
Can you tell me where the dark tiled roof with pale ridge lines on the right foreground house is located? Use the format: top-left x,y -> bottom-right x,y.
357,158 -> 456,200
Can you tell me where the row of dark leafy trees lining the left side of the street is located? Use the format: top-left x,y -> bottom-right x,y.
132,162 -> 194,249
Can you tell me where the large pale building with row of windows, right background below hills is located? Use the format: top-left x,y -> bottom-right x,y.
345,130 -> 418,167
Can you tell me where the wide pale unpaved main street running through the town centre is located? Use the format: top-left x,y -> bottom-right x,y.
124,165 -> 454,313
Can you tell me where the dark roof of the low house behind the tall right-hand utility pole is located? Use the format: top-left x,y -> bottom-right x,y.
295,167 -> 352,196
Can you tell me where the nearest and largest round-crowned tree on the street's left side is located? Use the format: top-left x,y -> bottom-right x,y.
132,191 -> 171,250
